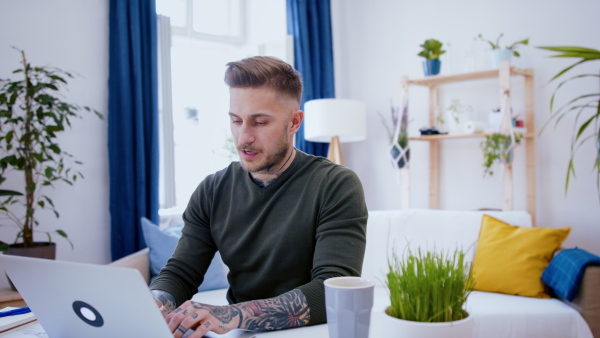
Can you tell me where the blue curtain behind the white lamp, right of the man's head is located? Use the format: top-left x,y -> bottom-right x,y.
287,0 -> 335,156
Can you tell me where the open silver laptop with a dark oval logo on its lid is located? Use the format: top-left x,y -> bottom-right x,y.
0,255 -> 253,338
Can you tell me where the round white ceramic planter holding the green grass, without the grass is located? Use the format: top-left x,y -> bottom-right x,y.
381,311 -> 473,338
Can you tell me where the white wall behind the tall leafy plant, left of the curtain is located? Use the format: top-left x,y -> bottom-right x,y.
0,0 -> 110,284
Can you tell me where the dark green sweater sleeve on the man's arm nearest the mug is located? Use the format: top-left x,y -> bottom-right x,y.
298,166 -> 368,325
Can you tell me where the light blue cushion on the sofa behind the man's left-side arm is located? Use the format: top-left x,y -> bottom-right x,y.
141,217 -> 229,291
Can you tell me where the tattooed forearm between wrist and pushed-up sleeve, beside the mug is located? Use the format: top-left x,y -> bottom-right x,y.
235,290 -> 310,331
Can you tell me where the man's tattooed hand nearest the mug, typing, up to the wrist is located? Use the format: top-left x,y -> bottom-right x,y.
165,301 -> 243,338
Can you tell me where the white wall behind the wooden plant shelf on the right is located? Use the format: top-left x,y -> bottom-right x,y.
332,0 -> 600,254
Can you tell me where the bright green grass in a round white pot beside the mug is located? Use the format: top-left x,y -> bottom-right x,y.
382,249 -> 475,338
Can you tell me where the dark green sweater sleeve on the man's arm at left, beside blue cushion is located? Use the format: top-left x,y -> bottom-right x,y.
150,176 -> 217,306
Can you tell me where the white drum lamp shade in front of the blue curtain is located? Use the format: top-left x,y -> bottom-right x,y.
304,99 -> 367,142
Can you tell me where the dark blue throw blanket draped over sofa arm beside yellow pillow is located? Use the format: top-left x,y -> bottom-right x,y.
542,248 -> 600,302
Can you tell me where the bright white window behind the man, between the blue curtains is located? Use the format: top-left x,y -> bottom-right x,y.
156,0 -> 293,214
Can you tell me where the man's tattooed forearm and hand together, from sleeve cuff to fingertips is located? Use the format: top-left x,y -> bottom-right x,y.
165,289 -> 310,338
